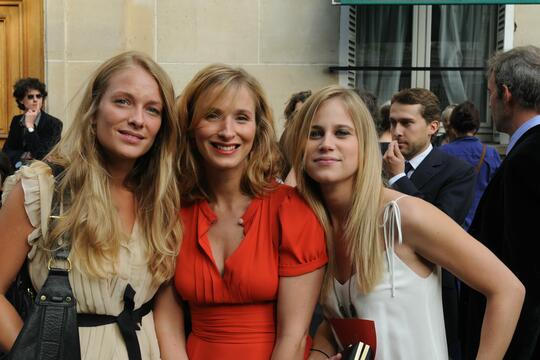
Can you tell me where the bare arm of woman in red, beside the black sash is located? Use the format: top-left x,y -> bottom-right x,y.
154,281 -> 188,360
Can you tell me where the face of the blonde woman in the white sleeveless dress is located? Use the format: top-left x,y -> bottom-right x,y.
305,98 -> 359,190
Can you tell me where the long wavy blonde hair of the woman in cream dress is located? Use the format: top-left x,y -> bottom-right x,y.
45,52 -> 182,284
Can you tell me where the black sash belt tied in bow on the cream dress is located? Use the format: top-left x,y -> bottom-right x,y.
77,284 -> 152,360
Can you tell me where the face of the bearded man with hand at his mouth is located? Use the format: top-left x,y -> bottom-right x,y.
390,102 -> 439,160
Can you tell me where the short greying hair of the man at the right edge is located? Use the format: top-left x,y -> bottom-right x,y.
487,45 -> 540,112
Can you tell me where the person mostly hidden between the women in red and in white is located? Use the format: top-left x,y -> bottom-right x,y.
279,90 -> 311,186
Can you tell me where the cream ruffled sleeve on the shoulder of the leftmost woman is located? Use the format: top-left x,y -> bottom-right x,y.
2,161 -> 54,260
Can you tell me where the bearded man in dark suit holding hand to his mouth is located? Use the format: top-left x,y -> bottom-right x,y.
383,89 -> 476,359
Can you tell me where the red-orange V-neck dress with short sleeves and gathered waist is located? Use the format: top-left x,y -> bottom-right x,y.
175,185 -> 328,360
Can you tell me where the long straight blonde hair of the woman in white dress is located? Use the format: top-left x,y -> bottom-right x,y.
289,85 -> 384,299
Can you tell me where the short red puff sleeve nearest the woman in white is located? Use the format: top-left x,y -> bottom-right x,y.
278,189 -> 328,276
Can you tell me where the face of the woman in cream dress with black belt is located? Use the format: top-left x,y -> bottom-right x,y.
93,65 -> 163,170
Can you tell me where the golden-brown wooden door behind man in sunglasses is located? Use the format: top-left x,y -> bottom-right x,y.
0,0 -> 44,146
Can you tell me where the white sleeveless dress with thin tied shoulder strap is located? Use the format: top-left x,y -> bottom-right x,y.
324,198 -> 448,360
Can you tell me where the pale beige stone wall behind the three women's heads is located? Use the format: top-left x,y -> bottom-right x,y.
45,0 -> 339,134
